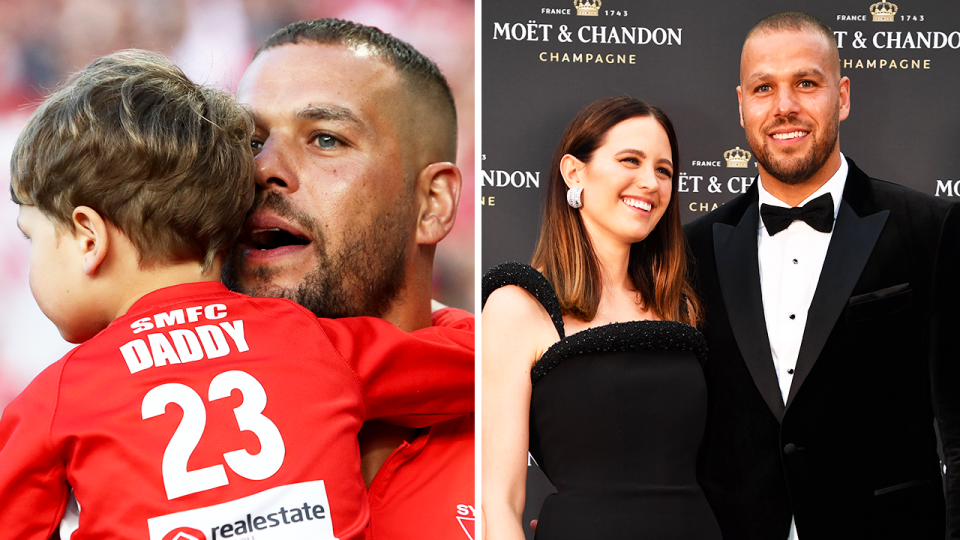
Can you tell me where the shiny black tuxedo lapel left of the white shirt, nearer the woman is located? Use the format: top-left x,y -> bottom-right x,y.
713,201 -> 784,421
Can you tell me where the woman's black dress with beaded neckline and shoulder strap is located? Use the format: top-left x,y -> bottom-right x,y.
483,263 -> 720,540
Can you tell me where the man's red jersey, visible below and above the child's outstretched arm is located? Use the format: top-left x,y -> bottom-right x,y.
367,308 -> 476,540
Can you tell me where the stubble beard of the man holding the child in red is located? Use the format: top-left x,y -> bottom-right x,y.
223,189 -> 413,319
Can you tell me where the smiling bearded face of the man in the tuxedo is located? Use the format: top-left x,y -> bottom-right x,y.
737,31 -> 850,184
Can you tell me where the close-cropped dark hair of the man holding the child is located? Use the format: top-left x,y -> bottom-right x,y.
253,19 -> 457,159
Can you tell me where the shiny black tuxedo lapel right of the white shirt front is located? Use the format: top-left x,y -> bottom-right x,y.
787,202 -> 890,408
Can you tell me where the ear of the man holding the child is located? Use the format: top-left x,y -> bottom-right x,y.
416,161 -> 463,245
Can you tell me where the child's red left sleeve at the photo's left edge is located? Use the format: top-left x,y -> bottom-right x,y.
0,362 -> 70,540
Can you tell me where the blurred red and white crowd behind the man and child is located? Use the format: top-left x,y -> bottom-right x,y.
0,0 -> 475,409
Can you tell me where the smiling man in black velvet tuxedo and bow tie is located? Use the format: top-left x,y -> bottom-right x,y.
686,13 -> 960,540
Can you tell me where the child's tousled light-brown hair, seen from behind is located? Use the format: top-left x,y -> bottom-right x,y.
10,49 -> 255,269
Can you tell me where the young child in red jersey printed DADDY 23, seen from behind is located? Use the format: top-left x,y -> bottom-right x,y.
0,51 -> 473,540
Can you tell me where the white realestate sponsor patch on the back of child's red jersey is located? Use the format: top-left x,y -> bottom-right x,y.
147,480 -> 337,540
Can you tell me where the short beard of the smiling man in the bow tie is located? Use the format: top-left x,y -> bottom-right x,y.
744,111 -> 840,185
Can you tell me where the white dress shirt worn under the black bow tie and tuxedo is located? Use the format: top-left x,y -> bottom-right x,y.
757,154 -> 848,540
